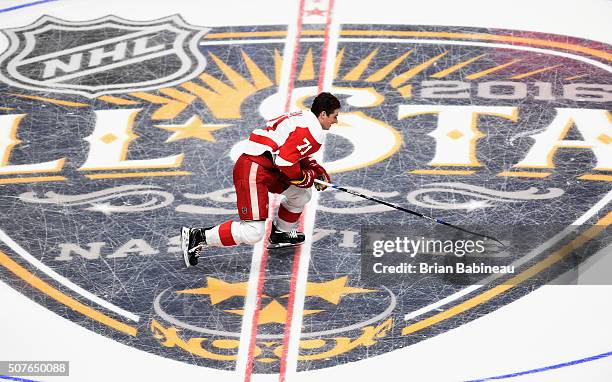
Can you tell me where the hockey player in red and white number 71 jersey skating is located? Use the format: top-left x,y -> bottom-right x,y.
181,92 -> 340,267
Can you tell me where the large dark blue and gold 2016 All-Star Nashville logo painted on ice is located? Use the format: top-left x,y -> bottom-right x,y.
0,16 -> 612,373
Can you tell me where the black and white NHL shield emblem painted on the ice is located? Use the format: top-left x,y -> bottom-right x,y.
0,15 -> 210,98
